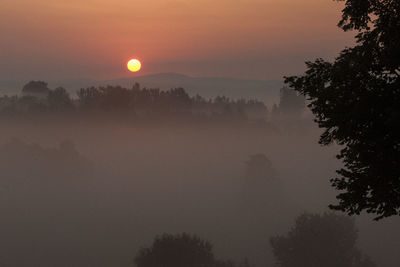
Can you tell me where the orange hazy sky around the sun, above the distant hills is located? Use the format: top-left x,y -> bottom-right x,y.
0,0 -> 353,80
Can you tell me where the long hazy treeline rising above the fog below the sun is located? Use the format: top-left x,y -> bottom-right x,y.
0,81 -> 268,122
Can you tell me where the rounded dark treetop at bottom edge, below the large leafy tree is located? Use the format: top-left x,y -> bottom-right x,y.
270,213 -> 375,267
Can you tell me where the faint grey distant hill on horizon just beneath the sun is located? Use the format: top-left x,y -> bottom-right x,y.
0,73 -> 283,107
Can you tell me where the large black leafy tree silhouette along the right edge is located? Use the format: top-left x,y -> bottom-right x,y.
286,0 -> 400,219
